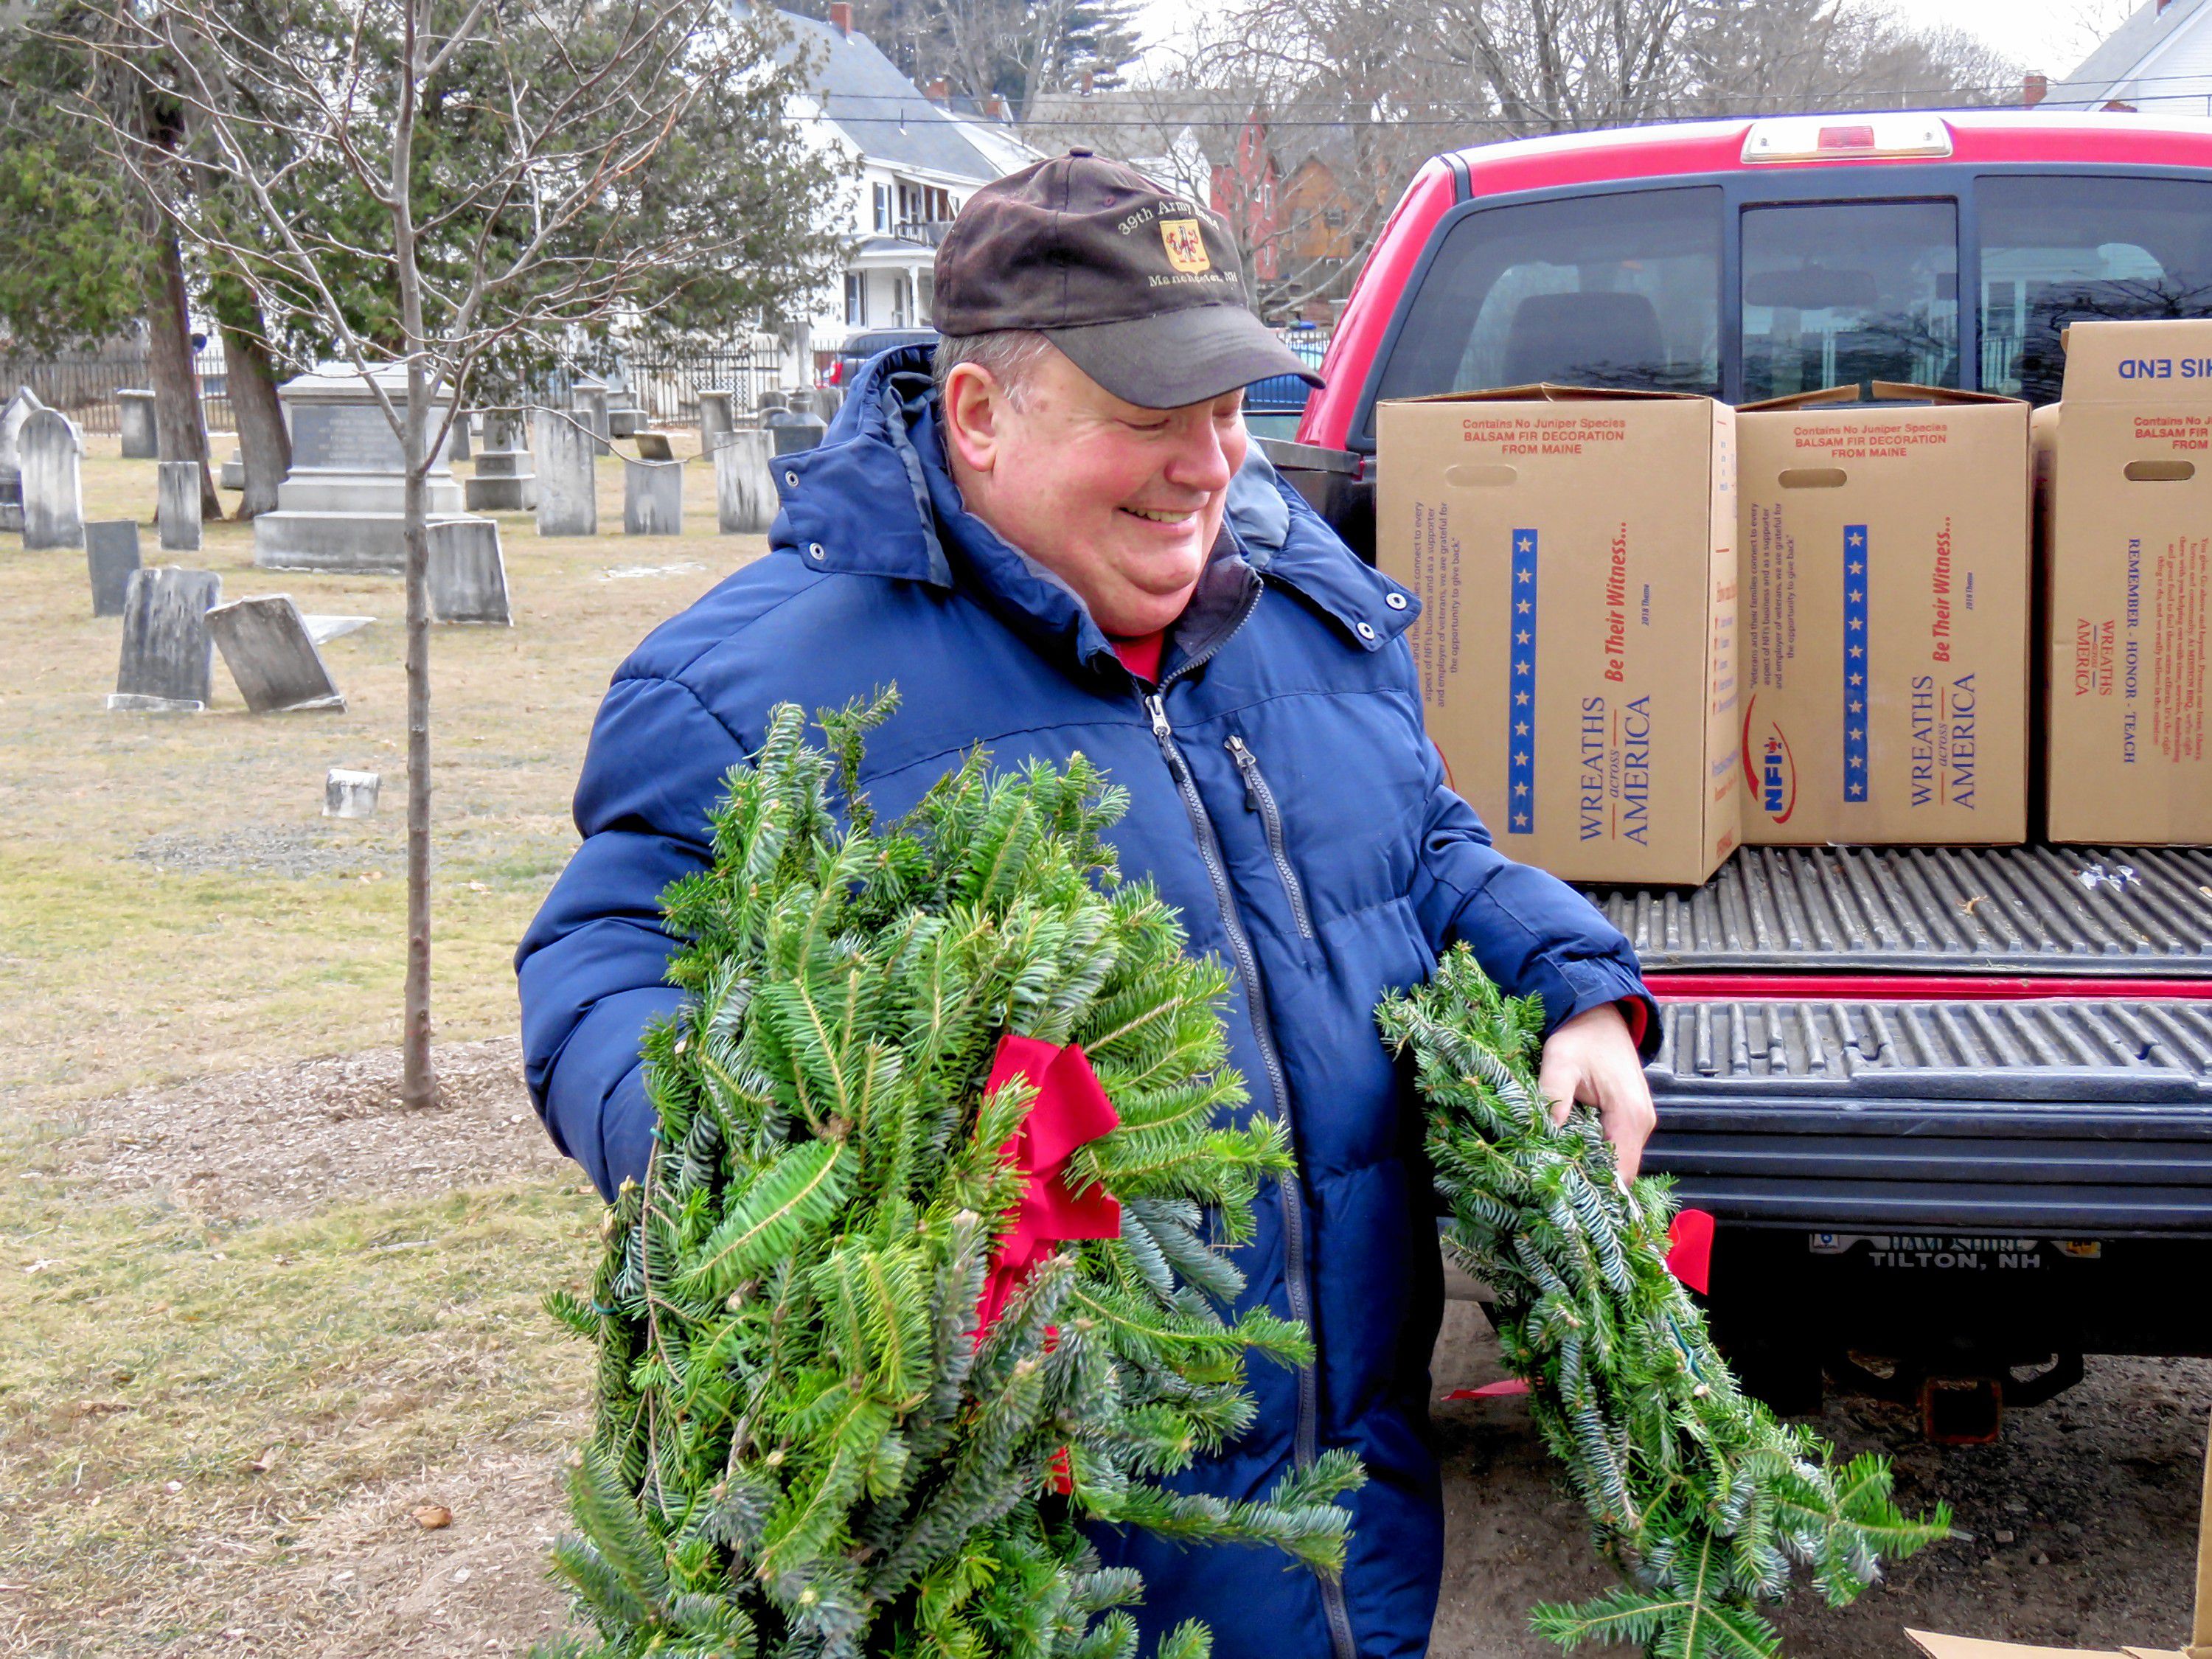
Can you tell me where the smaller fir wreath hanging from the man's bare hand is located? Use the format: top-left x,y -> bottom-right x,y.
1376,947 -> 1951,1659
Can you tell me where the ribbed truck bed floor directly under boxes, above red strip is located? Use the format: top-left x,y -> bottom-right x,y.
1586,845 -> 2212,978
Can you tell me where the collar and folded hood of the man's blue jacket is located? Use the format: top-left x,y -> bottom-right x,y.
768,345 -> 1420,670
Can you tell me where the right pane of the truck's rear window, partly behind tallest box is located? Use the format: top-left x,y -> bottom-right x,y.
1978,177 -> 2212,403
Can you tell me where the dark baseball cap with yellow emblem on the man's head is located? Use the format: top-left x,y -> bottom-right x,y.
929,150 -> 1321,409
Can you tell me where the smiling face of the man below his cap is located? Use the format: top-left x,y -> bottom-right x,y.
945,349 -> 1245,635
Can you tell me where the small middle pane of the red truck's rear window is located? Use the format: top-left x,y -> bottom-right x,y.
1743,201 -> 1958,403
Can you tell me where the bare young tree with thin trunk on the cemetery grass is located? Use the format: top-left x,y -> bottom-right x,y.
73,0 -> 830,1106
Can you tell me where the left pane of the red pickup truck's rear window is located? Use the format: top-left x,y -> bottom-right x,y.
1369,186 -> 1721,431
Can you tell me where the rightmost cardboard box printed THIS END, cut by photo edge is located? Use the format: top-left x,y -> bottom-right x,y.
2037,321 -> 2212,843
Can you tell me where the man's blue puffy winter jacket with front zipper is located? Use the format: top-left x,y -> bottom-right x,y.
515,349 -> 1657,1659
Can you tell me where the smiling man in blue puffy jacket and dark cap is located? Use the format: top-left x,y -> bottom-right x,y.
518,150 -> 1657,1659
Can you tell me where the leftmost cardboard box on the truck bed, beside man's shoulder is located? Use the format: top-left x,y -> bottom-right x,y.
1376,387 -> 1739,883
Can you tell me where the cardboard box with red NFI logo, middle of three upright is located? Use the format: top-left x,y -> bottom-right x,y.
1736,380 -> 2028,845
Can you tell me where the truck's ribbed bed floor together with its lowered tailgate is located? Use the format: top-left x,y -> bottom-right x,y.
1590,847 -> 2212,1239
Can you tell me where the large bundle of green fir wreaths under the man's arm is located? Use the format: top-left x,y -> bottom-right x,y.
549,697 -> 1363,1659
